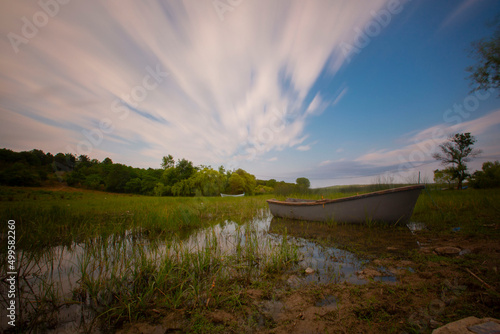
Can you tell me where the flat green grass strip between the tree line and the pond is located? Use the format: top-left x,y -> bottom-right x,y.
0,187 -> 267,253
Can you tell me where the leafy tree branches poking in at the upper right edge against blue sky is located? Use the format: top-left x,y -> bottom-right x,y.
467,19 -> 500,94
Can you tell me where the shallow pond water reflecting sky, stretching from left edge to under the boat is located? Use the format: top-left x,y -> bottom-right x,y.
0,211 -> 417,333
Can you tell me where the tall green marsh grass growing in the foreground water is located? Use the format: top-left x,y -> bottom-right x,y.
55,220 -> 298,327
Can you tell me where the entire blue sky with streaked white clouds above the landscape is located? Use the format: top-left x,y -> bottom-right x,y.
0,0 -> 500,187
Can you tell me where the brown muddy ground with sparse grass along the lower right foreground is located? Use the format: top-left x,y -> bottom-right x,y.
118,225 -> 500,334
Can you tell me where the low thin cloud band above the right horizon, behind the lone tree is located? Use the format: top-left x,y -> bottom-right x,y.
298,110 -> 500,187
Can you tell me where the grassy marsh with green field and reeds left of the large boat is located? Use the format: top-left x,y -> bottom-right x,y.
0,188 -> 298,331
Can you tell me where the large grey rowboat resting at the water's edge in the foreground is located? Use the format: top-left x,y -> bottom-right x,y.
267,185 -> 424,224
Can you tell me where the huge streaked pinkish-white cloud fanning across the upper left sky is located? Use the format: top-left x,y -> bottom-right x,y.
0,0 -> 386,166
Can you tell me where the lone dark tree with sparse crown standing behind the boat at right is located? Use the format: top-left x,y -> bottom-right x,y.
432,132 -> 481,189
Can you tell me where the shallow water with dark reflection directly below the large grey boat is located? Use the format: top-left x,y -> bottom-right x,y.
269,218 -> 418,284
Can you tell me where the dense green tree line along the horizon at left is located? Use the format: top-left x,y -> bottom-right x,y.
0,148 -> 309,196
